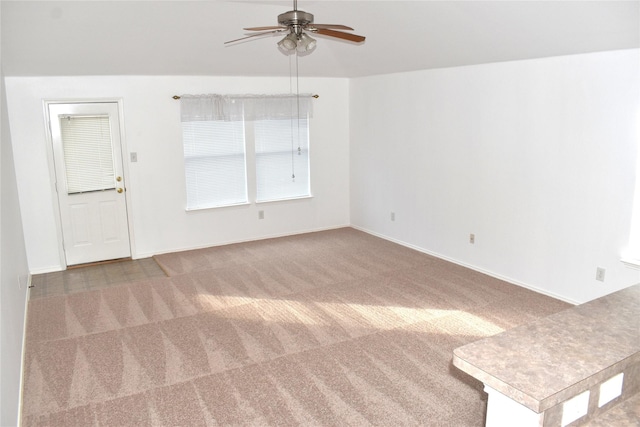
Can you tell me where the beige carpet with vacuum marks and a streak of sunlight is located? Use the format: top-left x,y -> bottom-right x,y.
23,228 -> 568,427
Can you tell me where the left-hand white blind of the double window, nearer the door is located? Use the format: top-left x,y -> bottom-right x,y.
182,121 -> 248,209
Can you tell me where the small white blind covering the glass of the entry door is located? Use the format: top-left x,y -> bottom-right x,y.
60,116 -> 116,194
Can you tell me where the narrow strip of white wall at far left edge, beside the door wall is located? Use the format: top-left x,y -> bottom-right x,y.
0,66 -> 29,426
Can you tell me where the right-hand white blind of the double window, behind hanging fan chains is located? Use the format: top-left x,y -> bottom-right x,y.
254,118 -> 310,202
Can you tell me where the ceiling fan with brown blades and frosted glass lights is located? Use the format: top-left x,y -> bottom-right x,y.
225,0 -> 365,53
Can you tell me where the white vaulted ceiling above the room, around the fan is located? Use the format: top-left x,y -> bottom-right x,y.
0,0 -> 640,77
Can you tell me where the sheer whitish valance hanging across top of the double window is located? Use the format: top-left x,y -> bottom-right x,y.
180,94 -> 313,122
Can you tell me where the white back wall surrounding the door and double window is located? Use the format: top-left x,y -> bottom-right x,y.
6,76 -> 349,273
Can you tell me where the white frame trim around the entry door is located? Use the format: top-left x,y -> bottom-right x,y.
42,98 -> 137,270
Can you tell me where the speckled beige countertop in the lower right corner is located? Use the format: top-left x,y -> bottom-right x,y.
453,284 -> 640,413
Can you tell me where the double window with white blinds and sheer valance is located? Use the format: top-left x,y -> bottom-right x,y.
181,95 -> 311,210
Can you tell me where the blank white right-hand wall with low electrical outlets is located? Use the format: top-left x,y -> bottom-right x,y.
349,50 -> 640,302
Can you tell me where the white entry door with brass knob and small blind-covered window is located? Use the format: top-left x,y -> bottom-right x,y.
49,102 -> 131,265
